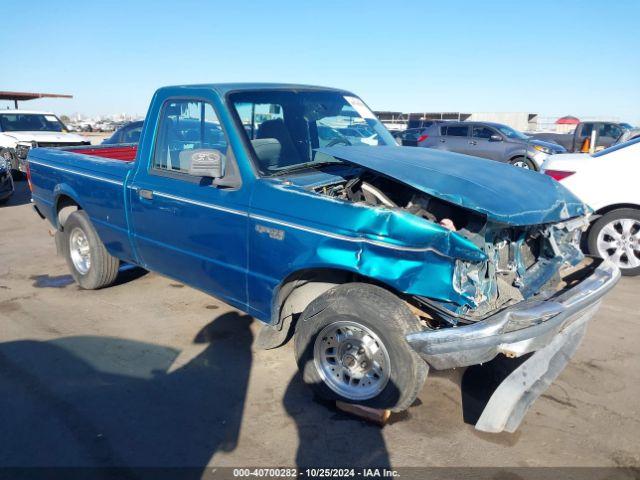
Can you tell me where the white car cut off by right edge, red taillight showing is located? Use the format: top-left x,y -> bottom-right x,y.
541,138 -> 640,275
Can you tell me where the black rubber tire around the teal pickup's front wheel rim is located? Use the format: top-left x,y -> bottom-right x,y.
294,283 -> 429,411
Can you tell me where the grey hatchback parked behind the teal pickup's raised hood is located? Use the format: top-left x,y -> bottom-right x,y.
418,122 -> 566,170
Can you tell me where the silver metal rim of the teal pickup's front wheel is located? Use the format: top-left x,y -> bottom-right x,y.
313,321 -> 391,400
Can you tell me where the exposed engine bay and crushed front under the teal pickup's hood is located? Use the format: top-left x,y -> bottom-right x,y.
314,170 -> 589,325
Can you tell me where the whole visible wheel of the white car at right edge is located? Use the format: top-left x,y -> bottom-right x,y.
587,208 -> 640,275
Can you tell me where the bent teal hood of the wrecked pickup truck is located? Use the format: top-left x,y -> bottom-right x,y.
318,146 -> 589,225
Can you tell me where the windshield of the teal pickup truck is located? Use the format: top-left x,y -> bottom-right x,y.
229,90 -> 397,176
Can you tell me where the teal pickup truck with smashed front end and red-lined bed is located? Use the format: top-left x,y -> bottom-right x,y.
28,84 -> 619,431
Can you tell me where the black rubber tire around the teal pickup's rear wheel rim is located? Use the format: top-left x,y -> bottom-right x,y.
62,210 -> 120,290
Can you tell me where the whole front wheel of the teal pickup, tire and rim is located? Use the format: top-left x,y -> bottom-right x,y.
294,283 -> 428,411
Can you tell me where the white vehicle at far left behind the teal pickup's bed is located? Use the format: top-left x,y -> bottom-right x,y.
0,110 -> 91,172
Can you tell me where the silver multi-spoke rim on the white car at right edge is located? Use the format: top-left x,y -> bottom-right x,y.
597,218 -> 640,268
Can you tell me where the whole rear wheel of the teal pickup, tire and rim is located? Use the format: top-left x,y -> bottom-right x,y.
62,210 -> 120,290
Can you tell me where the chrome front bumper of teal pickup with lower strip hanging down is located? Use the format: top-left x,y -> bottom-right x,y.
407,260 -> 620,433
